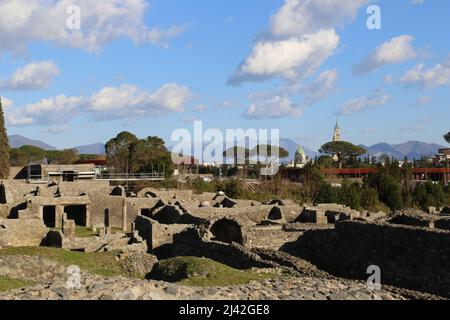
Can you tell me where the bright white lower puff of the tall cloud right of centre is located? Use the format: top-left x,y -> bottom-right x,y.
228,30 -> 339,84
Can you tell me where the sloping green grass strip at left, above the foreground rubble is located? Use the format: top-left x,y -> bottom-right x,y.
0,247 -> 130,277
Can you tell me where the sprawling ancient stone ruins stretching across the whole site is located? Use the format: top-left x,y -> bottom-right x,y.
0,175 -> 450,297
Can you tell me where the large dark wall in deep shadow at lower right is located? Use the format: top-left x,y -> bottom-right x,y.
284,222 -> 450,297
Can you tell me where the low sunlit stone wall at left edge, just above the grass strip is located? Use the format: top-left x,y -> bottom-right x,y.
0,219 -> 47,248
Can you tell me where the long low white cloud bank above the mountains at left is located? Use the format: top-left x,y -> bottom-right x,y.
5,83 -> 194,126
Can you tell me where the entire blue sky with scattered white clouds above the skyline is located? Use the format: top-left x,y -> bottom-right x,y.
0,0 -> 450,149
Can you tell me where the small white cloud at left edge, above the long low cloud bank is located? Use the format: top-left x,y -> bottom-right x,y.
0,61 -> 59,91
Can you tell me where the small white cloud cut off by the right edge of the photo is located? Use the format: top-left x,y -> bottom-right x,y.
400,63 -> 450,89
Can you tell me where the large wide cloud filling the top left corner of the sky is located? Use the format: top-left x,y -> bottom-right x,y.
0,0 -> 183,53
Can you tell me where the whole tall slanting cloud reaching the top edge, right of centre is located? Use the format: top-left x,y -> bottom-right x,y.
228,0 -> 369,85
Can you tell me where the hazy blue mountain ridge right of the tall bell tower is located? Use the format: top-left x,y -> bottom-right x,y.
361,141 -> 444,160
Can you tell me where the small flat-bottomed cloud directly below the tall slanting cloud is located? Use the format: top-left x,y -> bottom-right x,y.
243,96 -> 302,120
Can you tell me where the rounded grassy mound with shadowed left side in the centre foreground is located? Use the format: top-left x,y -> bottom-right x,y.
149,257 -> 277,287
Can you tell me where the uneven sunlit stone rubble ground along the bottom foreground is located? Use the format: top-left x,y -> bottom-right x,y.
0,274 -> 405,300
